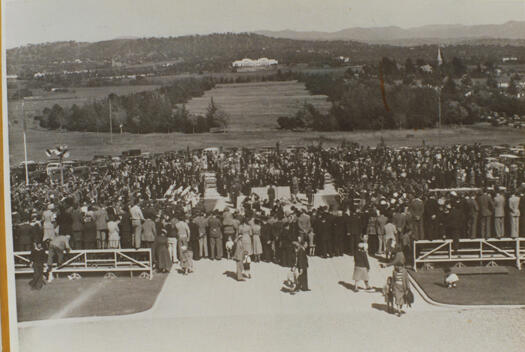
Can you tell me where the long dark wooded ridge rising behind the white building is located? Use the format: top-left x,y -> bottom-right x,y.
7,33 -> 524,79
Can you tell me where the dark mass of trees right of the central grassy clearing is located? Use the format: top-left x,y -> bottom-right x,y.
278,58 -> 525,131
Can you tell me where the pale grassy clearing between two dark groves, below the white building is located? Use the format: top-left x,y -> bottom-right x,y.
186,81 -> 330,131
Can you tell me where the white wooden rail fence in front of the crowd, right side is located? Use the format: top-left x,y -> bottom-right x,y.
413,237 -> 525,270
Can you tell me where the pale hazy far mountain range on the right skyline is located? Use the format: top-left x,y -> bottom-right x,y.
255,21 -> 525,45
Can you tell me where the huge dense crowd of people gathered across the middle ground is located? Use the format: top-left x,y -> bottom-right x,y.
11,144 -> 525,289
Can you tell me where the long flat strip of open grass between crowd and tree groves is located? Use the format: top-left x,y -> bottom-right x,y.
9,124 -> 525,165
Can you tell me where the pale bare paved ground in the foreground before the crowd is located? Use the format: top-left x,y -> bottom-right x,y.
19,256 -> 525,352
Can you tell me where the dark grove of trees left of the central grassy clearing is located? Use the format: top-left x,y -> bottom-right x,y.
35,78 -> 227,133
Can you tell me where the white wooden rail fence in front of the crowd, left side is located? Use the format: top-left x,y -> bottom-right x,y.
14,248 -> 153,279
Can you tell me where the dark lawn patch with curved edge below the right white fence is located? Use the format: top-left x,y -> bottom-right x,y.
410,268 -> 525,305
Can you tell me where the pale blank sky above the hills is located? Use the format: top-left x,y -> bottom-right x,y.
2,0 -> 525,48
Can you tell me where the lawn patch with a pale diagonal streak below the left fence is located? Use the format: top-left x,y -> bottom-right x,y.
16,274 -> 167,321
